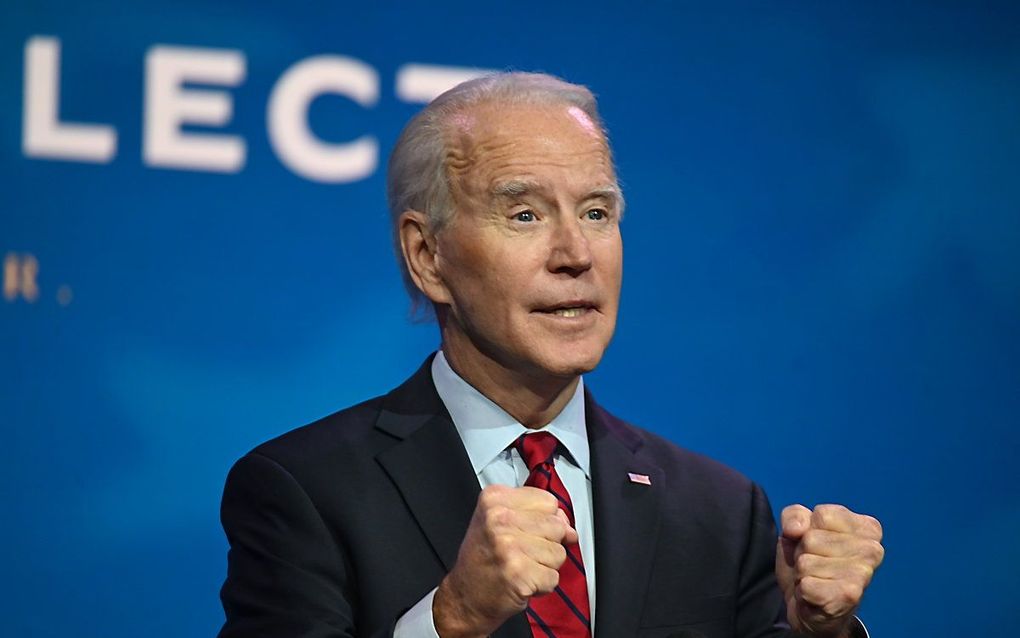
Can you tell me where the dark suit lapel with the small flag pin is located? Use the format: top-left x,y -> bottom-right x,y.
585,394 -> 664,636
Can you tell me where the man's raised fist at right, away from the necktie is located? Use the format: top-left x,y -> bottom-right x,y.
775,505 -> 885,638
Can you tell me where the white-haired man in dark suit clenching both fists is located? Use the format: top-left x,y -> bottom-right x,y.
220,73 -> 882,638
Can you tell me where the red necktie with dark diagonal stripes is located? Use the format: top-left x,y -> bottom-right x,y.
514,432 -> 592,638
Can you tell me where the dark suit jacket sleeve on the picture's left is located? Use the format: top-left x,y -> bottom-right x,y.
219,452 -> 396,638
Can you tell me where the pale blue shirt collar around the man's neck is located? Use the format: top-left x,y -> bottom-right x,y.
432,350 -> 592,479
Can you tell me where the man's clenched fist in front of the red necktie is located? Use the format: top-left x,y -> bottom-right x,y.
432,485 -> 577,638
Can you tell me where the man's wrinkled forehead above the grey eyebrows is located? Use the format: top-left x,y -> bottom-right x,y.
445,103 -> 615,195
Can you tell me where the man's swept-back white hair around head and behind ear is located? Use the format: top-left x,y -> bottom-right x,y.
387,72 -> 609,315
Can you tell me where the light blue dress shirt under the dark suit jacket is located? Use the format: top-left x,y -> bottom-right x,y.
394,350 -> 595,638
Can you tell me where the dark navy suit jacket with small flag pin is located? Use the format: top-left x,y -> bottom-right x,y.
219,359 -> 789,638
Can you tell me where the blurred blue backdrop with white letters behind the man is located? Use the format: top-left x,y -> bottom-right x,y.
0,0 -> 1020,638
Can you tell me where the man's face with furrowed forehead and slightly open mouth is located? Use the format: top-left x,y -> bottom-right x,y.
436,104 -> 623,378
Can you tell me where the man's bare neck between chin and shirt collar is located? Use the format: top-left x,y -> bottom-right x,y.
443,340 -> 580,430
